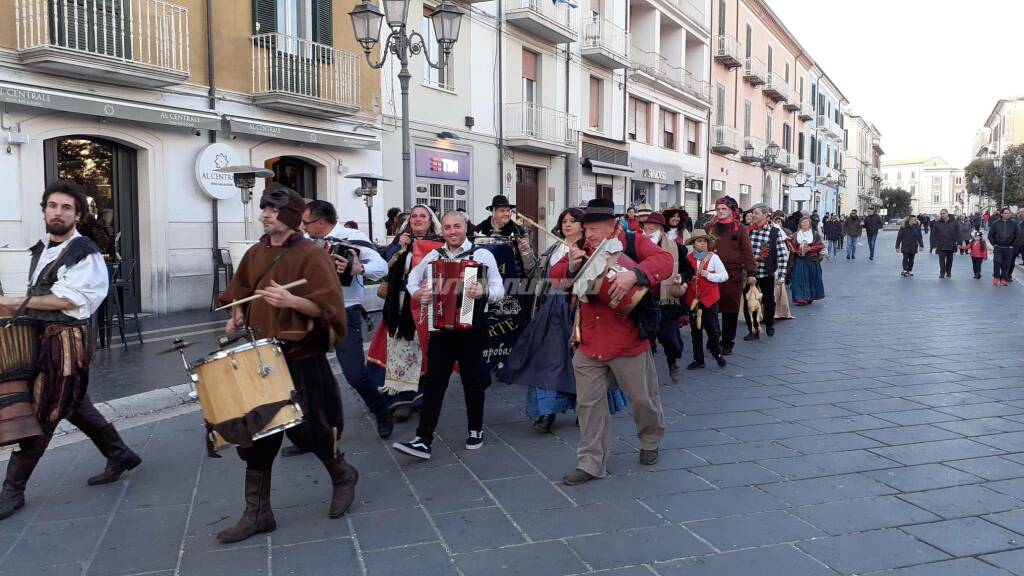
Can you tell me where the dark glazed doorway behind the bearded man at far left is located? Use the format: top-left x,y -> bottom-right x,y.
43,135 -> 141,312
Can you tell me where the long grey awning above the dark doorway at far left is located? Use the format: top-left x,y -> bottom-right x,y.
0,83 -> 220,130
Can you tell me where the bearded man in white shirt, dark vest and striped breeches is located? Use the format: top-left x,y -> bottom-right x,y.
0,180 -> 142,519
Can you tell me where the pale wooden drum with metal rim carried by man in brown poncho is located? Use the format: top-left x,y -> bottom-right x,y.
191,339 -> 302,448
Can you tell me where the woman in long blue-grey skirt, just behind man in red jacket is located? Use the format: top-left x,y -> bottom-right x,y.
509,208 -> 627,433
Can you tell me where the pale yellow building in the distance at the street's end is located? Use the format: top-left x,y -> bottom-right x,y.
882,156 -> 962,214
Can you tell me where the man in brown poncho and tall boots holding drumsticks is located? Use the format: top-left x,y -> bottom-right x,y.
217,183 -> 359,543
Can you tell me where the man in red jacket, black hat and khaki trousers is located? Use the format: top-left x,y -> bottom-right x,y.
551,198 -> 673,486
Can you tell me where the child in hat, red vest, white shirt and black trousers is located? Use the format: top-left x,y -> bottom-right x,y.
683,230 -> 729,370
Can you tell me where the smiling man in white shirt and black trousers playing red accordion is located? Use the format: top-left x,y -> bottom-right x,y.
392,211 -> 505,460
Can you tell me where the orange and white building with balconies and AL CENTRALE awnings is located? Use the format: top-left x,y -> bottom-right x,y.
0,0 -> 383,313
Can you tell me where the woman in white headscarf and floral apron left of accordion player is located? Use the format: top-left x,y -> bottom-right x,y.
367,204 -> 443,422
